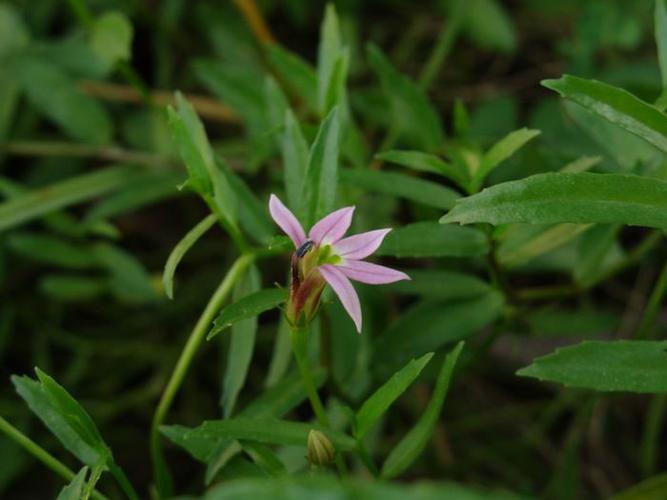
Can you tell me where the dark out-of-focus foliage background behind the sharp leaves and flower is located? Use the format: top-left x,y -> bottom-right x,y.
0,0 -> 667,498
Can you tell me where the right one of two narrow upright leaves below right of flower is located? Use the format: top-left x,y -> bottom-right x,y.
382,342 -> 463,479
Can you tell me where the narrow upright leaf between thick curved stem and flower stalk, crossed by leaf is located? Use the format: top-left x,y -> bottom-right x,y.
220,266 -> 261,418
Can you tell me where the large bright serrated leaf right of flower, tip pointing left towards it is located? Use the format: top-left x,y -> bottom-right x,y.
440,172 -> 667,227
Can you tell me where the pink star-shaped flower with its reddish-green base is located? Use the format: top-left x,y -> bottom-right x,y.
269,194 -> 410,333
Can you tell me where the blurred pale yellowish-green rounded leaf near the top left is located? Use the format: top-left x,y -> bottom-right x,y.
90,11 -> 134,66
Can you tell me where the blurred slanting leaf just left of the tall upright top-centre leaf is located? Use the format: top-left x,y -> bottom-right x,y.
264,44 -> 318,113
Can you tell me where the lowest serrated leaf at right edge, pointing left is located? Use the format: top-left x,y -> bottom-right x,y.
517,340 -> 667,393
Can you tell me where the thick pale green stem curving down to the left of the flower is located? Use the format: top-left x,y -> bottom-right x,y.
150,254 -> 255,498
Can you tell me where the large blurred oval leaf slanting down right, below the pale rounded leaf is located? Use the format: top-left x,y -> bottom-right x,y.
16,57 -> 112,144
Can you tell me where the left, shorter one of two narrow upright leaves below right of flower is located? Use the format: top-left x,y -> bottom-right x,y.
355,352 -> 433,439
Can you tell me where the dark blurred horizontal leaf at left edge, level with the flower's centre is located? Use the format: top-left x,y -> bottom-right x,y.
7,233 -> 96,269
